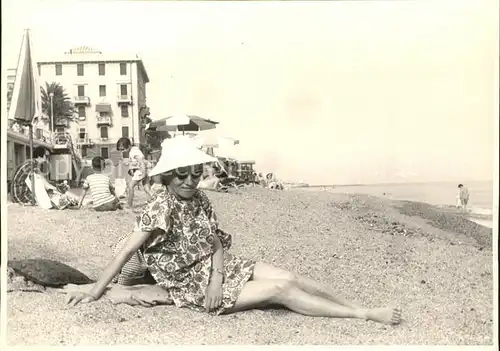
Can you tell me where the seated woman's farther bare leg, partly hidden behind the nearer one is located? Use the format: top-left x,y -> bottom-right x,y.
252,262 -> 361,308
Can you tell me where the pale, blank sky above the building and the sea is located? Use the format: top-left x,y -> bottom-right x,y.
1,0 -> 499,184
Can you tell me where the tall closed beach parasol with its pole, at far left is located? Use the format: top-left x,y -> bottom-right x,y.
8,29 -> 42,204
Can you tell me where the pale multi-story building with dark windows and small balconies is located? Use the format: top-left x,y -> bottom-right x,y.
38,47 -> 149,158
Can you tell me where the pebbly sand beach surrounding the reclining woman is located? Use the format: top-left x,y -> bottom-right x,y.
7,188 -> 493,345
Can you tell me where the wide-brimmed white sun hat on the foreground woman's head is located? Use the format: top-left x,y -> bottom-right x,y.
149,138 -> 217,176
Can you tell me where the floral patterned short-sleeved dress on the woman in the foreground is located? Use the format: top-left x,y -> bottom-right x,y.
116,190 -> 255,314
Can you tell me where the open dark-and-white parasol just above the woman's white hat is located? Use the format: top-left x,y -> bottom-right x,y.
146,115 -> 219,133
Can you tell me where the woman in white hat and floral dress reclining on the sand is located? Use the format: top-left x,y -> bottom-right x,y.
67,139 -> 401,324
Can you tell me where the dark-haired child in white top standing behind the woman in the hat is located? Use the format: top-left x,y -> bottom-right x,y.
116,138 -> 152,207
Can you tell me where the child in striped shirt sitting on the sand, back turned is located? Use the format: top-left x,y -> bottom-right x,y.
78,156 -> 121,212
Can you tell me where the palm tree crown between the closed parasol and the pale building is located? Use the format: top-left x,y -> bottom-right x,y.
41,82 -> 76,129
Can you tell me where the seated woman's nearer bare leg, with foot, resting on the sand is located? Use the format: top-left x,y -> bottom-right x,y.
227,280 -> 401,324
